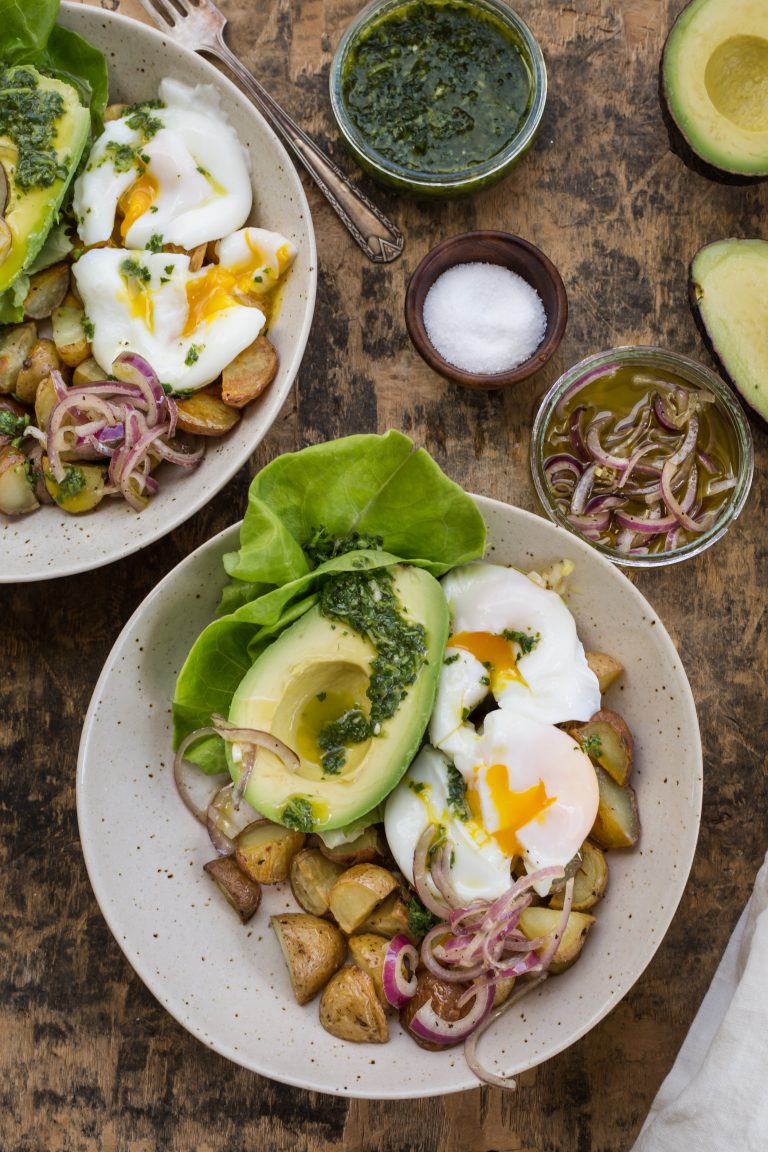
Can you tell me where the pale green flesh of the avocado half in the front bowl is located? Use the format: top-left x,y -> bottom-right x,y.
228,566 -> 448,832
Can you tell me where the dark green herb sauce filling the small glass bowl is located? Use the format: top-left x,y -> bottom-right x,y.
341,0 -> 533,175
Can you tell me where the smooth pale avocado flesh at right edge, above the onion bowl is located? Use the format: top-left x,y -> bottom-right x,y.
691,240 -> 768,419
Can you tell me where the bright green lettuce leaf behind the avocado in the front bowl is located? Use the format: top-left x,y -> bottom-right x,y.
173,431 -> 486,772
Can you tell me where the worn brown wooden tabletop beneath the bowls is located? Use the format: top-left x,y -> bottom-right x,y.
0,0 -> 768,1152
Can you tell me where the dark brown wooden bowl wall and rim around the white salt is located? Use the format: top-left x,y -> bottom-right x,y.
405,228 -> 568,392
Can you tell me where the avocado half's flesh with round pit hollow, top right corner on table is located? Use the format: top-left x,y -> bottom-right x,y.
661,0 -> 768,176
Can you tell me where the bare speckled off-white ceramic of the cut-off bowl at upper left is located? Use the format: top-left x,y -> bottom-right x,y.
0,3 -> 317,583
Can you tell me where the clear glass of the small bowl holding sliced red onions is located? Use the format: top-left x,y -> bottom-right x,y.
531,346 -> 754,568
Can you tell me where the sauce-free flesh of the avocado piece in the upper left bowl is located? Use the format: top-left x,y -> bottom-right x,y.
0,66 -> 91,293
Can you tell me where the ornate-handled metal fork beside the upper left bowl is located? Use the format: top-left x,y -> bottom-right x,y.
140,0 -> 404,264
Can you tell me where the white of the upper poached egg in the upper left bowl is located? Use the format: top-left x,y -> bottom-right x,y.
73,79 -> 253,249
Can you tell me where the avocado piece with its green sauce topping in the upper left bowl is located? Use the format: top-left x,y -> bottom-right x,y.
0,66 -> 91,293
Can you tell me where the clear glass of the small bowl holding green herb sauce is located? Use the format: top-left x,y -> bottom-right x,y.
329,0 -> 547,197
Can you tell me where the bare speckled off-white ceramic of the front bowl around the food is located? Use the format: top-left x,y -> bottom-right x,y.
77,499 -> 701,1098
